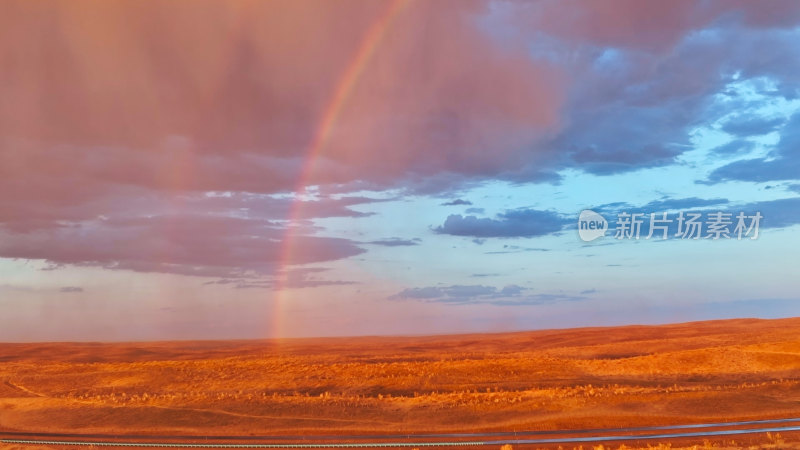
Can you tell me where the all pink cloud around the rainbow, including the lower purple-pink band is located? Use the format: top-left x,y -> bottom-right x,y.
0,0 -> 562,277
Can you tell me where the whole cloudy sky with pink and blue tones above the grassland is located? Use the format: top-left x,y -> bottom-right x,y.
0,0 -> 800,341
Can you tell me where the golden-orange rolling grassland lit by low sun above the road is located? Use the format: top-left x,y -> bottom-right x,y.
0,318 -> 800,449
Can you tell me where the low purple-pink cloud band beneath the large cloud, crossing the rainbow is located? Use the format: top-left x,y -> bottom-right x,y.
0,215 -> 363,277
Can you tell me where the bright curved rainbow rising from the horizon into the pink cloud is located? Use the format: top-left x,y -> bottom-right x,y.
270,0 -> 410,338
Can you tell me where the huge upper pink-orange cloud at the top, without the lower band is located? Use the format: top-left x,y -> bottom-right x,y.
0,1 -> 562,185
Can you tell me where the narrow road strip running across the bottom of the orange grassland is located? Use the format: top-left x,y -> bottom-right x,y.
0,418 -> 800,448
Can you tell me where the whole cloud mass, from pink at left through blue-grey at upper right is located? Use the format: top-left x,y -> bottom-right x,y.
0,0 -> 798,277
